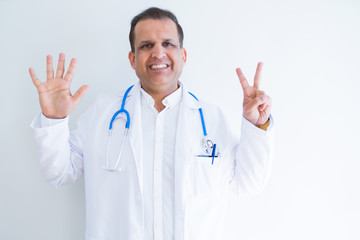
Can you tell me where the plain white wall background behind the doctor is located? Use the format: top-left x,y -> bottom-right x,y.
0,0 -> 360,240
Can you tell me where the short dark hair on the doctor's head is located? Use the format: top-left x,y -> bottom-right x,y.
129,7 -> 184,52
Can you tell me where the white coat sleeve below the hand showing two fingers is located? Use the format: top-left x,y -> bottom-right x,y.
232,116 -> 274,193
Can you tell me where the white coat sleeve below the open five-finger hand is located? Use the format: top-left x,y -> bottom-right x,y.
30,103 -> 95,187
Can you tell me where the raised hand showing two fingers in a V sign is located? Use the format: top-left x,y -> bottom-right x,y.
236,62 -> 271,126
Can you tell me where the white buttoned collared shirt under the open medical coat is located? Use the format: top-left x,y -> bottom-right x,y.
141,86 -> 182,240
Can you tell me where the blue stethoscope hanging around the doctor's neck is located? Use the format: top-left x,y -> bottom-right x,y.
103,85 -> 217,172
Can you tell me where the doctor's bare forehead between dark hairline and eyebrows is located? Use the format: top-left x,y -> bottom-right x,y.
134,19 -> 178,43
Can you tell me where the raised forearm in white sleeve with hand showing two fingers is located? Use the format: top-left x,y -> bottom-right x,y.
234,63 -> 273,192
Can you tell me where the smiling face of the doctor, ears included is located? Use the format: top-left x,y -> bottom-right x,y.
129,19 -> 186,94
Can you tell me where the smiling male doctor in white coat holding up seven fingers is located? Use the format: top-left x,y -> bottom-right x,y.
29,8 -> 273,240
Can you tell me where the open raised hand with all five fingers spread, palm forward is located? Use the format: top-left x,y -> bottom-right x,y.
29,53 -> 89,118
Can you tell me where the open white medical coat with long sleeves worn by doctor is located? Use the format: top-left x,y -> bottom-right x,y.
32,83 -> 272,240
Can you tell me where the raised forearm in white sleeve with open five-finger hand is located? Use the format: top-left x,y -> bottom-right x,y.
29,54 -> 88,186
